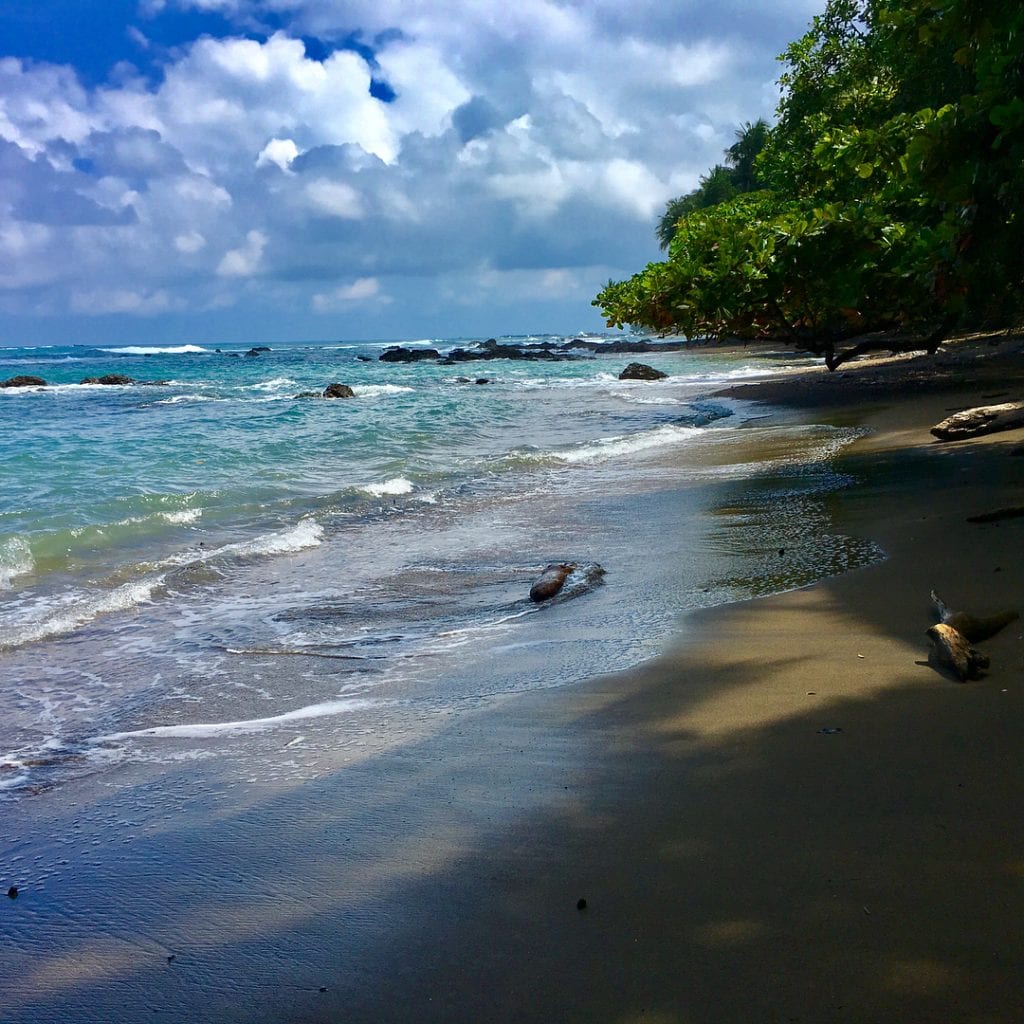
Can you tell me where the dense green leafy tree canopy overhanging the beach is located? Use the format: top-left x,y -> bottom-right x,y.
594,0 -> 1024,369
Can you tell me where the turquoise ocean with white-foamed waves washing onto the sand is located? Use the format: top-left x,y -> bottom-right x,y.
0,336 -> 880,807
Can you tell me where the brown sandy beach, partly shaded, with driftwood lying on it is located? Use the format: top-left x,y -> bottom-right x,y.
0,339 -> 1024,1024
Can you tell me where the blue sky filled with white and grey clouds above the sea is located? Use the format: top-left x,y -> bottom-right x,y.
0,0 -> 823,345
